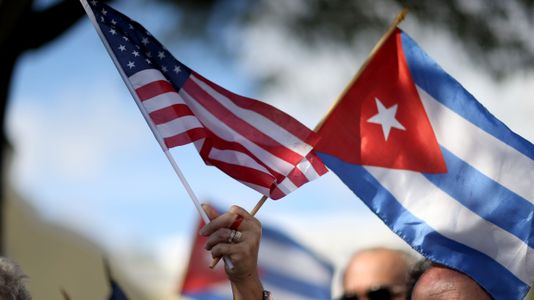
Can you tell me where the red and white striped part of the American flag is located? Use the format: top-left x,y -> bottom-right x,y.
129,69 -> 326,199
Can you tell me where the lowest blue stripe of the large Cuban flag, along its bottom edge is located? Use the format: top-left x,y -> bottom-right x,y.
317,153 -> 529,299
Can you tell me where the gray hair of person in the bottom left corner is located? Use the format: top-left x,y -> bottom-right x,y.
0,257 -> 31,300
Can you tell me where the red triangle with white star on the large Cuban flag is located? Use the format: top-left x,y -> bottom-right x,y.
316,29 -> 447,173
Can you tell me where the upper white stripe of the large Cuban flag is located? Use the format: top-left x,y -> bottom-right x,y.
417,87 -> 534,203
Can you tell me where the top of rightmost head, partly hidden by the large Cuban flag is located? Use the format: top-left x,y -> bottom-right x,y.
411,265 -> 491,300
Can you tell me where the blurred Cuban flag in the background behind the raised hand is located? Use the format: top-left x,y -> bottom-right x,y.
181,217 -> 334,300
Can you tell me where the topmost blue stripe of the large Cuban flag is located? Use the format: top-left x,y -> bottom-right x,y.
402,32 -> 534,160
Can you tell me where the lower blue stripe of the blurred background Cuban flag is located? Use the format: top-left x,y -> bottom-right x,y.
260,268 -> 332,300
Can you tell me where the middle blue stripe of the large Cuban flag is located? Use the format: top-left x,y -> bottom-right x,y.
424,146 -> 534,247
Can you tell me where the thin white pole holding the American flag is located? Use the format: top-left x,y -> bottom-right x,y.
80,0 -> 234,269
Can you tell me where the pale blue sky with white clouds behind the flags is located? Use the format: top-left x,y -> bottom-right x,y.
8,0 -> 534,296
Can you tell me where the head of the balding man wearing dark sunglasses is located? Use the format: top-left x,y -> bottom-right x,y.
341,248 -> 413,300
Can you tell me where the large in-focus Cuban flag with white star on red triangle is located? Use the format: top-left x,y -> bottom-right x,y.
317,29 -> 534,299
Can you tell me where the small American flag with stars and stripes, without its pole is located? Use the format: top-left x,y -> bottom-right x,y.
86,0 -> 327,199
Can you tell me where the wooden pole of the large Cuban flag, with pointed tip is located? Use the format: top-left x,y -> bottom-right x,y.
210,8 -> 408,269
